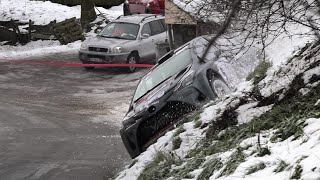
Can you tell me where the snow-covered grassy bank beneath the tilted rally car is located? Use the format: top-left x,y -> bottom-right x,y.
117,41 -> 320,180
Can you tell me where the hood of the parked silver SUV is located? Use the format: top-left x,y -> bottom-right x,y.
86,36 -> 132,48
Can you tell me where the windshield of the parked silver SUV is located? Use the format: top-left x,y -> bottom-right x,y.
99,22 -> 140,40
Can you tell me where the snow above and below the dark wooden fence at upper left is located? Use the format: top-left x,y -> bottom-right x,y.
0,0 -> 123,59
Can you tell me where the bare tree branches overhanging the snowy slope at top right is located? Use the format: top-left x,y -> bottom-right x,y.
168,0 -> 320,61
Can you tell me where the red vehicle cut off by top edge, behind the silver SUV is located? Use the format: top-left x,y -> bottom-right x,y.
123,0 -> 165,15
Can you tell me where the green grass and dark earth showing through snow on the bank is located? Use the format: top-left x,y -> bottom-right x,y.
139,60 -> 320,179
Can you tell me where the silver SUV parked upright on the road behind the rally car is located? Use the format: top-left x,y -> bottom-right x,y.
79,14 -> 167,72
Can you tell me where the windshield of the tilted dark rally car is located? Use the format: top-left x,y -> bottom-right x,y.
133,48 -> 192,102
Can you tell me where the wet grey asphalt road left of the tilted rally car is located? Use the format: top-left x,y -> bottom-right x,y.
0,53 -> 146,180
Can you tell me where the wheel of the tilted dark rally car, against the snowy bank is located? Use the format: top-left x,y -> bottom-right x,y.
208,72 -> 231,98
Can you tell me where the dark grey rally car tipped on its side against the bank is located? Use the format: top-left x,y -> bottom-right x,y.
120,37 -> 230,158
